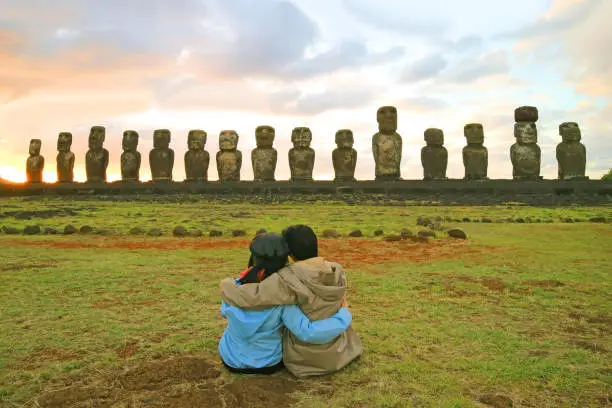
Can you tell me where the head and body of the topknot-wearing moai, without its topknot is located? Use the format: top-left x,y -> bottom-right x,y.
510,122 -> 542,180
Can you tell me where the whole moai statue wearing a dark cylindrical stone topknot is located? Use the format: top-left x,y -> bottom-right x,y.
510,106 -> 542,180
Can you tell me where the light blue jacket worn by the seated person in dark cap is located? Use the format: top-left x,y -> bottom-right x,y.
219,302 -> 353,368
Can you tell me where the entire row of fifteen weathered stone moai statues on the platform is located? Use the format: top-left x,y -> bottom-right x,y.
26,106 -> 587,182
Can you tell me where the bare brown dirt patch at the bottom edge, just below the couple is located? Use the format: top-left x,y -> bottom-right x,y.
34,356 -> 301,408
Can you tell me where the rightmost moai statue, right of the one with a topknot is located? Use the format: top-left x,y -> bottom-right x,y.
557,122 -> 588,180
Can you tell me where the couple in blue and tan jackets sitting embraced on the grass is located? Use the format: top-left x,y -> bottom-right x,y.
219,225 -> 362,377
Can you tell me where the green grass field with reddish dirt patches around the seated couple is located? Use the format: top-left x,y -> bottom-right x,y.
0,198 -> 612,408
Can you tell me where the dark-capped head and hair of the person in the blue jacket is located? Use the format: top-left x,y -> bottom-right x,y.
240,232 -> 289,284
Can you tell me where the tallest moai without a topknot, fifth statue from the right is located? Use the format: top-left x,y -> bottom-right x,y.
372,106 -> 402,181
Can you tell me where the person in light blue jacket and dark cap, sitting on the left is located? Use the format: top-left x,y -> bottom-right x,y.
219,233 -> 352,374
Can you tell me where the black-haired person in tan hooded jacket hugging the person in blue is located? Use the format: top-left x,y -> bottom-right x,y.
221,225 -> 363,377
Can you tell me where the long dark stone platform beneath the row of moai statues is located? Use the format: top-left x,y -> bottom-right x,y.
0,180 -> 612,205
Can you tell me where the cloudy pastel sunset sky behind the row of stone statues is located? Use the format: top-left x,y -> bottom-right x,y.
0,0 -> 612,182
